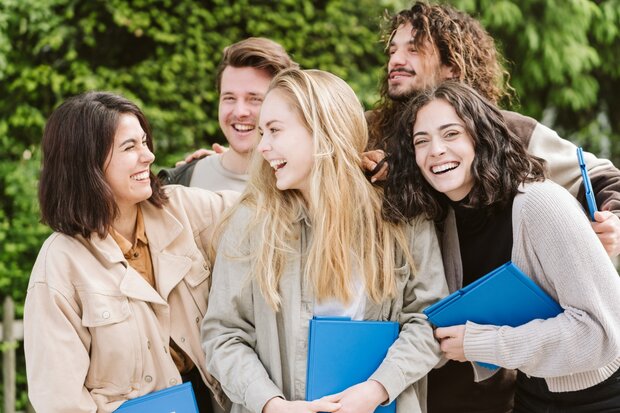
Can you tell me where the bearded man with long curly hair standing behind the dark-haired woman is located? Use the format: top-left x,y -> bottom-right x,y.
365,2 -> 620,257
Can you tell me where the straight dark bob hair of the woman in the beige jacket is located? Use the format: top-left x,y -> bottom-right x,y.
39,92 -> 167,238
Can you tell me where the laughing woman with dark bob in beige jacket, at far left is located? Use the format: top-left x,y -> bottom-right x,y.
24,92 -> 235,412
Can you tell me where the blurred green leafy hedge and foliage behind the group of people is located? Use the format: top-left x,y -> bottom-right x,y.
0,0 -> 620,409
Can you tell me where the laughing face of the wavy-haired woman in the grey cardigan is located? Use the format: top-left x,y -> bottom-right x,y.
413,99 -> 475,201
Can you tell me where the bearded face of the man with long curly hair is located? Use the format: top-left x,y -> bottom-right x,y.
388,23 -> 452,100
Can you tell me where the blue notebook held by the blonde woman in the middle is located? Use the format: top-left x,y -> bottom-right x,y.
306,317 -> 399,413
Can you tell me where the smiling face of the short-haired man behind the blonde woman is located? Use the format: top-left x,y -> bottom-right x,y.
218,66 -> 271,154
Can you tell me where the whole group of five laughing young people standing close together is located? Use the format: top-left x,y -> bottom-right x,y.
24,2 -> 620,413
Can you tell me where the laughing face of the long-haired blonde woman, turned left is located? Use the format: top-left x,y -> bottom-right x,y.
257,89 -> 314,201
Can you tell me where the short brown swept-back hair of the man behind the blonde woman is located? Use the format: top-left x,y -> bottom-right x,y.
216,37 -> 299,91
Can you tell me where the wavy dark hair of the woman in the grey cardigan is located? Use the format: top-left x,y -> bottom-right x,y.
383,81 -> 545,222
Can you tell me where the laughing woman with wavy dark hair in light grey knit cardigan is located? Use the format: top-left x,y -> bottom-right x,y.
384,82 -> 620,413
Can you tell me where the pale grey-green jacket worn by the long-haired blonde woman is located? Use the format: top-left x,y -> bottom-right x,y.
202,209 -> 447,413
